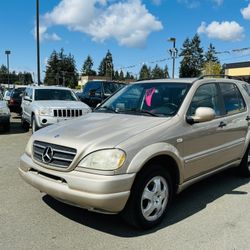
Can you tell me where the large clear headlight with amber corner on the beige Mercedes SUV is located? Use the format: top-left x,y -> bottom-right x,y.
78,149 -> 126,170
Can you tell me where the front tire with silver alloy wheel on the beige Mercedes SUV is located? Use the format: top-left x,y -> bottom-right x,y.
122,164 -> 173,229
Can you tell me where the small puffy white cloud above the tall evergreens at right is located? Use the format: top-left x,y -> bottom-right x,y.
197,21 -> 245,41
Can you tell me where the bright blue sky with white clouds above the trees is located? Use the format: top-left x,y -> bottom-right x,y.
0,0 -> 250,80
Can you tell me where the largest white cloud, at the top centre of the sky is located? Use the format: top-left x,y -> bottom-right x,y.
38,0 -> 163,47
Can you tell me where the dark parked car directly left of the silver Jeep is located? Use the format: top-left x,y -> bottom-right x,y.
7,87 -> 25,113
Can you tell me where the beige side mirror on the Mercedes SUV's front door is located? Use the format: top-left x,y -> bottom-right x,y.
186,107 -> 215,125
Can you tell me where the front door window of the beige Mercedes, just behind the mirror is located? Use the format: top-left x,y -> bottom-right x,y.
188,83 -> 221,116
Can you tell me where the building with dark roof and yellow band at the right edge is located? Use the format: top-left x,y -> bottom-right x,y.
224,61 -> 250,83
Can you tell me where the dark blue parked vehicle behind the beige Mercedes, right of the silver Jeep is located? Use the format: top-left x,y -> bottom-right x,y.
78,80 -> 125,108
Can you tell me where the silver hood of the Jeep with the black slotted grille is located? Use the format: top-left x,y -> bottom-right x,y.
35,100 -> 89,109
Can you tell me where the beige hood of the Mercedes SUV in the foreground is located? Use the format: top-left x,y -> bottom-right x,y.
34,113 -> 171,153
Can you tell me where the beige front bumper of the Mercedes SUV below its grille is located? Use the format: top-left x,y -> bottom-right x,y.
19,154 -> 135,213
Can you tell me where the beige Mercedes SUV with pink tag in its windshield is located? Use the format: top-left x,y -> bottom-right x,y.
19,77 -> 250,228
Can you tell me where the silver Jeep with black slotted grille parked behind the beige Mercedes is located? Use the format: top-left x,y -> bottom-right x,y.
21,86 -> 91,132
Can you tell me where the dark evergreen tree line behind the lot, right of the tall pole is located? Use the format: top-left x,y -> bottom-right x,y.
44,34 -> 223,88
